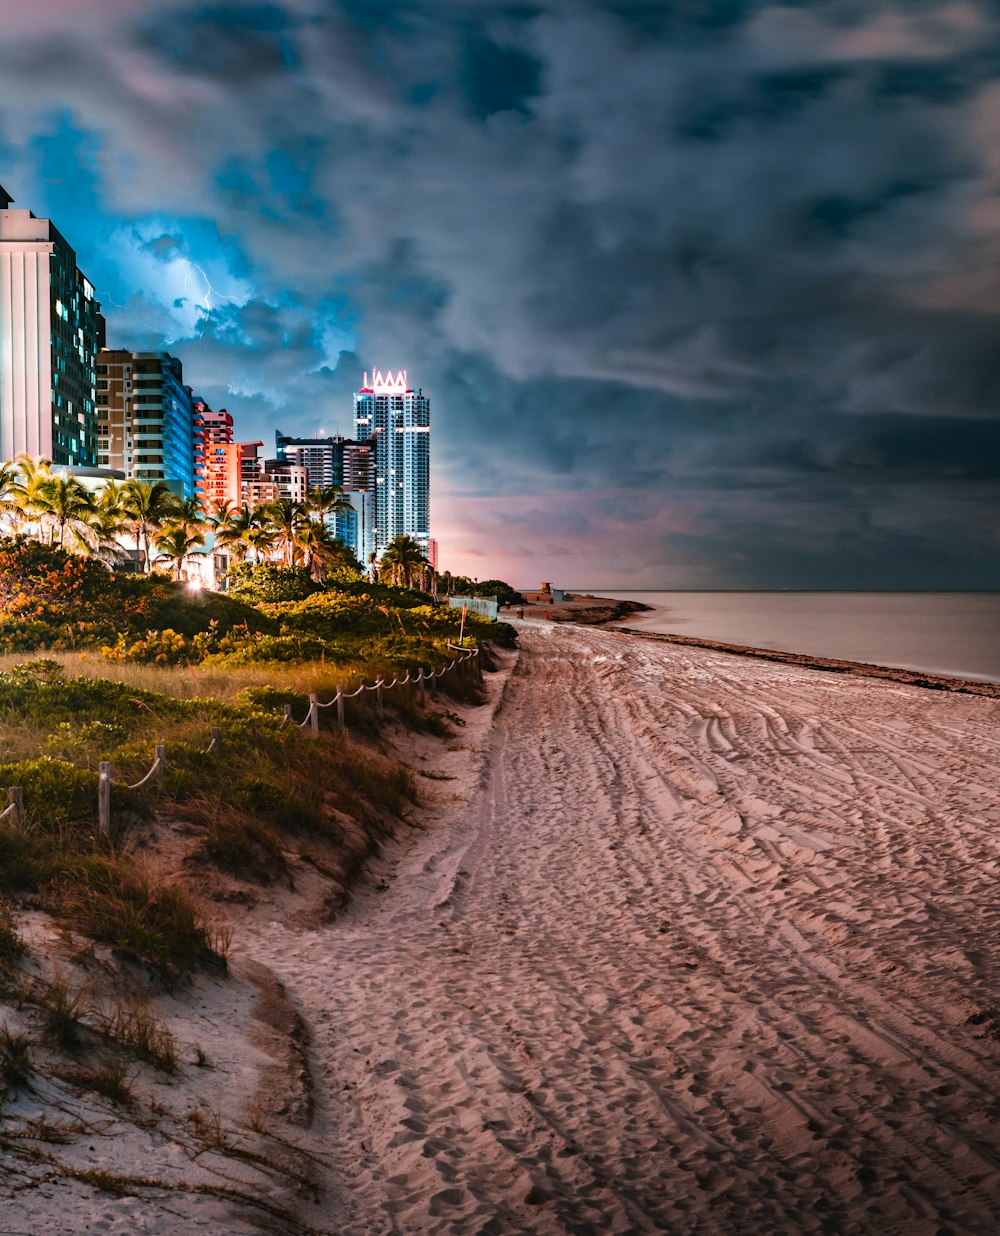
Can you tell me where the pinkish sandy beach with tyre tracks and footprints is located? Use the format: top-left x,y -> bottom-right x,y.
245,625 -> 1000,1236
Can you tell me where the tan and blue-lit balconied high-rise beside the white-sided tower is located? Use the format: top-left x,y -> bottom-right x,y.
98,349 -> 201,498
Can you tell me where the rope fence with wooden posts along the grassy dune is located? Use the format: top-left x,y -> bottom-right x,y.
0,644 -> 482,836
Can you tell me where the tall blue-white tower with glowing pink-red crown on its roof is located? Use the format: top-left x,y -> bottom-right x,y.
355,370 -> 430,554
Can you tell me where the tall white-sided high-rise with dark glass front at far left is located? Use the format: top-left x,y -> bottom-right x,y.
0,188 -> 104,467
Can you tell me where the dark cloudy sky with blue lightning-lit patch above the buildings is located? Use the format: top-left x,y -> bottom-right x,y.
0,0 -> 1000,590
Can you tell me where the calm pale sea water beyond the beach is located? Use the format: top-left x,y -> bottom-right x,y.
581,588 -> 1000,682
